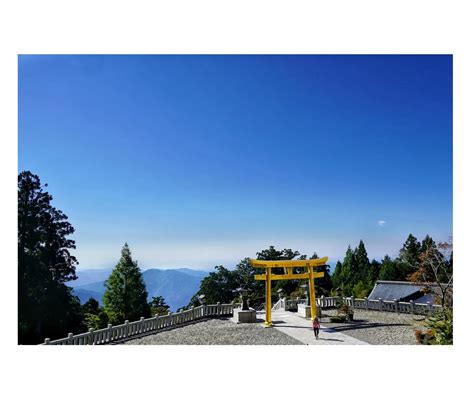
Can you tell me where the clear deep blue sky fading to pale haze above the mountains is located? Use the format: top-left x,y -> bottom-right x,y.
18,55 -> 453,270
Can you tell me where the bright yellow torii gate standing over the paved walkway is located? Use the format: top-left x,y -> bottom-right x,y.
250,256 -> 328,327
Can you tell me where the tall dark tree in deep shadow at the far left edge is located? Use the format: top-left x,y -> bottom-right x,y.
18,171 -> 81,344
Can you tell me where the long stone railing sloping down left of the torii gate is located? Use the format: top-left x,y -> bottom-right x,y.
41,303 -> 234,345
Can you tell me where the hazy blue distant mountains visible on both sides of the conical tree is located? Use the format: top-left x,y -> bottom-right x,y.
68,268 -> 210,311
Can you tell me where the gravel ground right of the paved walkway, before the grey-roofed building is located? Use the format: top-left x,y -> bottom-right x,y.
321,309 -> 425,345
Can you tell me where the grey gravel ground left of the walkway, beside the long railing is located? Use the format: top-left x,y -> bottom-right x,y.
123,319 -> 303,345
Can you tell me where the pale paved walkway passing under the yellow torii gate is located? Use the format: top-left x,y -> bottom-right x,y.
257,310 -> 369,345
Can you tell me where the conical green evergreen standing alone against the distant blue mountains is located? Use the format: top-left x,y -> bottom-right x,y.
103,243 -> 150,324
